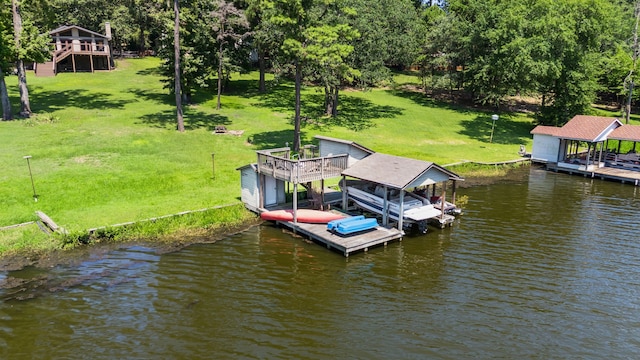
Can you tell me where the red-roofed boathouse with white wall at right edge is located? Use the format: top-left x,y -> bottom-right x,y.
531,115 -> 640,185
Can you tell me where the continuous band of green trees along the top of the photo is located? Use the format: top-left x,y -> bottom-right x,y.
0,0 -> 640,128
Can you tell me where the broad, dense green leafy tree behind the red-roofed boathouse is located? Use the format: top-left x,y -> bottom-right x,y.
438,0 -> 615,125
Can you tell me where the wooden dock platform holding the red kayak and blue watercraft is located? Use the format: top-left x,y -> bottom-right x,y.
268,212 -> 403,257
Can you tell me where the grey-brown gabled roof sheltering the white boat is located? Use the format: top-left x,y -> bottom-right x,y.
342,153 -> 464,189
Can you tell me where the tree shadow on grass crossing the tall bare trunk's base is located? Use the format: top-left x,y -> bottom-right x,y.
140,107 -> 231,131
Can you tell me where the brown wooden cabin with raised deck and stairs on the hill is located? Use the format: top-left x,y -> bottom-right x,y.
34,22 -> 114,76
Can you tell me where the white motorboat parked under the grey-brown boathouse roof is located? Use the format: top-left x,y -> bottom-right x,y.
346,185 -> 452,233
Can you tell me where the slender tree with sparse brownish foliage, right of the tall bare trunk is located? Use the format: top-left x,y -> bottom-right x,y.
211,0 -> 249,110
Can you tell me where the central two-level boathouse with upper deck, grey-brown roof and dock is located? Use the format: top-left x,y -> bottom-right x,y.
237,136 -> 462,256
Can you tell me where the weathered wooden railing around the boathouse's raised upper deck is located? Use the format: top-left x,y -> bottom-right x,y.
258,148 -> 349,184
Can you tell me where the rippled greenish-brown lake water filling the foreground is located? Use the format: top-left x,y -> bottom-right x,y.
0,169 -> 640,359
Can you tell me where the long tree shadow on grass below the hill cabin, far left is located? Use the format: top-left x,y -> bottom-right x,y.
30,88 -> 133,112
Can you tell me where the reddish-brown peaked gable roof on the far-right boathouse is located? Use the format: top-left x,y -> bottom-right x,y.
554,115 -> 622,142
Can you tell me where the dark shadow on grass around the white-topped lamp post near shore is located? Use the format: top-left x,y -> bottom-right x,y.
460,113 -> 532,145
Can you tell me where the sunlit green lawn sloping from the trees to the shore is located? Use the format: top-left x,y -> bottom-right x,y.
0,58 -> 533,253
